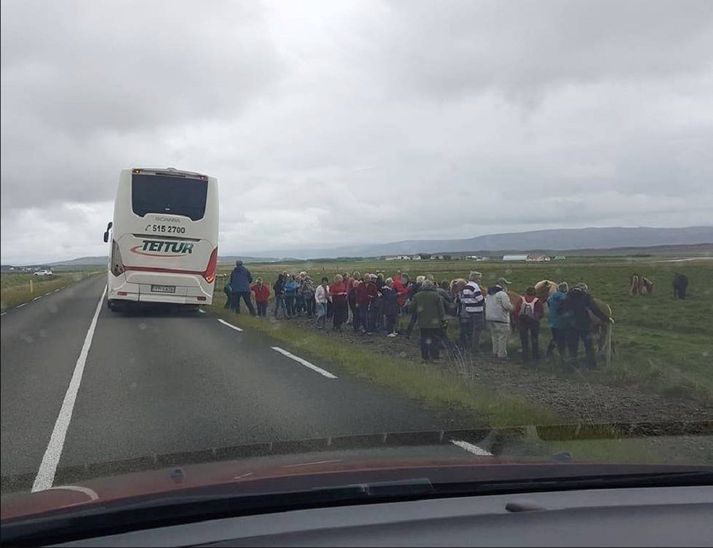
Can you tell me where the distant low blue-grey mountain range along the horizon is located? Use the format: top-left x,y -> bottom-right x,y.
4,226 -> 713,267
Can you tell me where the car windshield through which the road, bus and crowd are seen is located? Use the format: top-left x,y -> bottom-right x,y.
0,0 -> 713,532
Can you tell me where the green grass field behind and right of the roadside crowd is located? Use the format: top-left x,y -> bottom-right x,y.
211,258 -> 713,402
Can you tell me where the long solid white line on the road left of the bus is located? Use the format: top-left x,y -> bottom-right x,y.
32,286 -> 106,493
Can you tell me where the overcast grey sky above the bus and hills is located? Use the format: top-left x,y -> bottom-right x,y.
0,0 -> 713,263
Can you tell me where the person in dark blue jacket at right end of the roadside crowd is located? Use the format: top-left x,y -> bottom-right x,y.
563,283 -> 613,369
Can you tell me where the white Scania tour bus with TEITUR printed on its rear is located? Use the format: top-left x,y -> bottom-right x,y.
104,168 -> 218,310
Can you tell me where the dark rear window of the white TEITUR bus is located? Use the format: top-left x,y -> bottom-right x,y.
131,175 -> 208,221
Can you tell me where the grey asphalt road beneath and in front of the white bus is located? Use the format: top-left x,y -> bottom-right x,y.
1,277 -> 476,490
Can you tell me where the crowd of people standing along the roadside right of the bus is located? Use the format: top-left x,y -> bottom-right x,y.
224,261 -> 611,367
